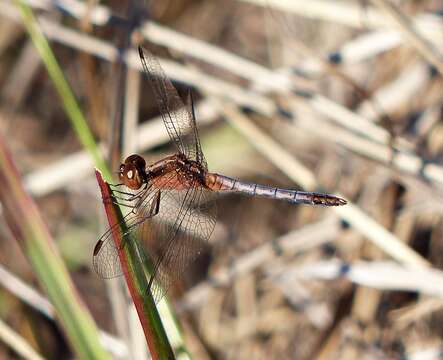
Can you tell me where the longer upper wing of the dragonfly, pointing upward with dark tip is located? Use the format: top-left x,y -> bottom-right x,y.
138,47 -> 206,169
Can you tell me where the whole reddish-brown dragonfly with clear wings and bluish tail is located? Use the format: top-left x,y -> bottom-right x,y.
93,47 -> 346,303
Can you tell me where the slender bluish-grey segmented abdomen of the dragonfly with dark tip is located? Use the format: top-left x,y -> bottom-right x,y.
206,174 -> 346,206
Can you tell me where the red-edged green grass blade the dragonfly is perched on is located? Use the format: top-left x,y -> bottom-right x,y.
95,170 -> 174,359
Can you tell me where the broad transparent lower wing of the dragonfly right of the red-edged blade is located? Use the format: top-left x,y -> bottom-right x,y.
142,187 -> 216,302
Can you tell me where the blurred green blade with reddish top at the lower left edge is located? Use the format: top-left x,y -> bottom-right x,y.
0,137 -> 107,359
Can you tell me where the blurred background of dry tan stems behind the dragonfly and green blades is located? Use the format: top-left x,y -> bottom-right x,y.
0,0 -> 443,359
